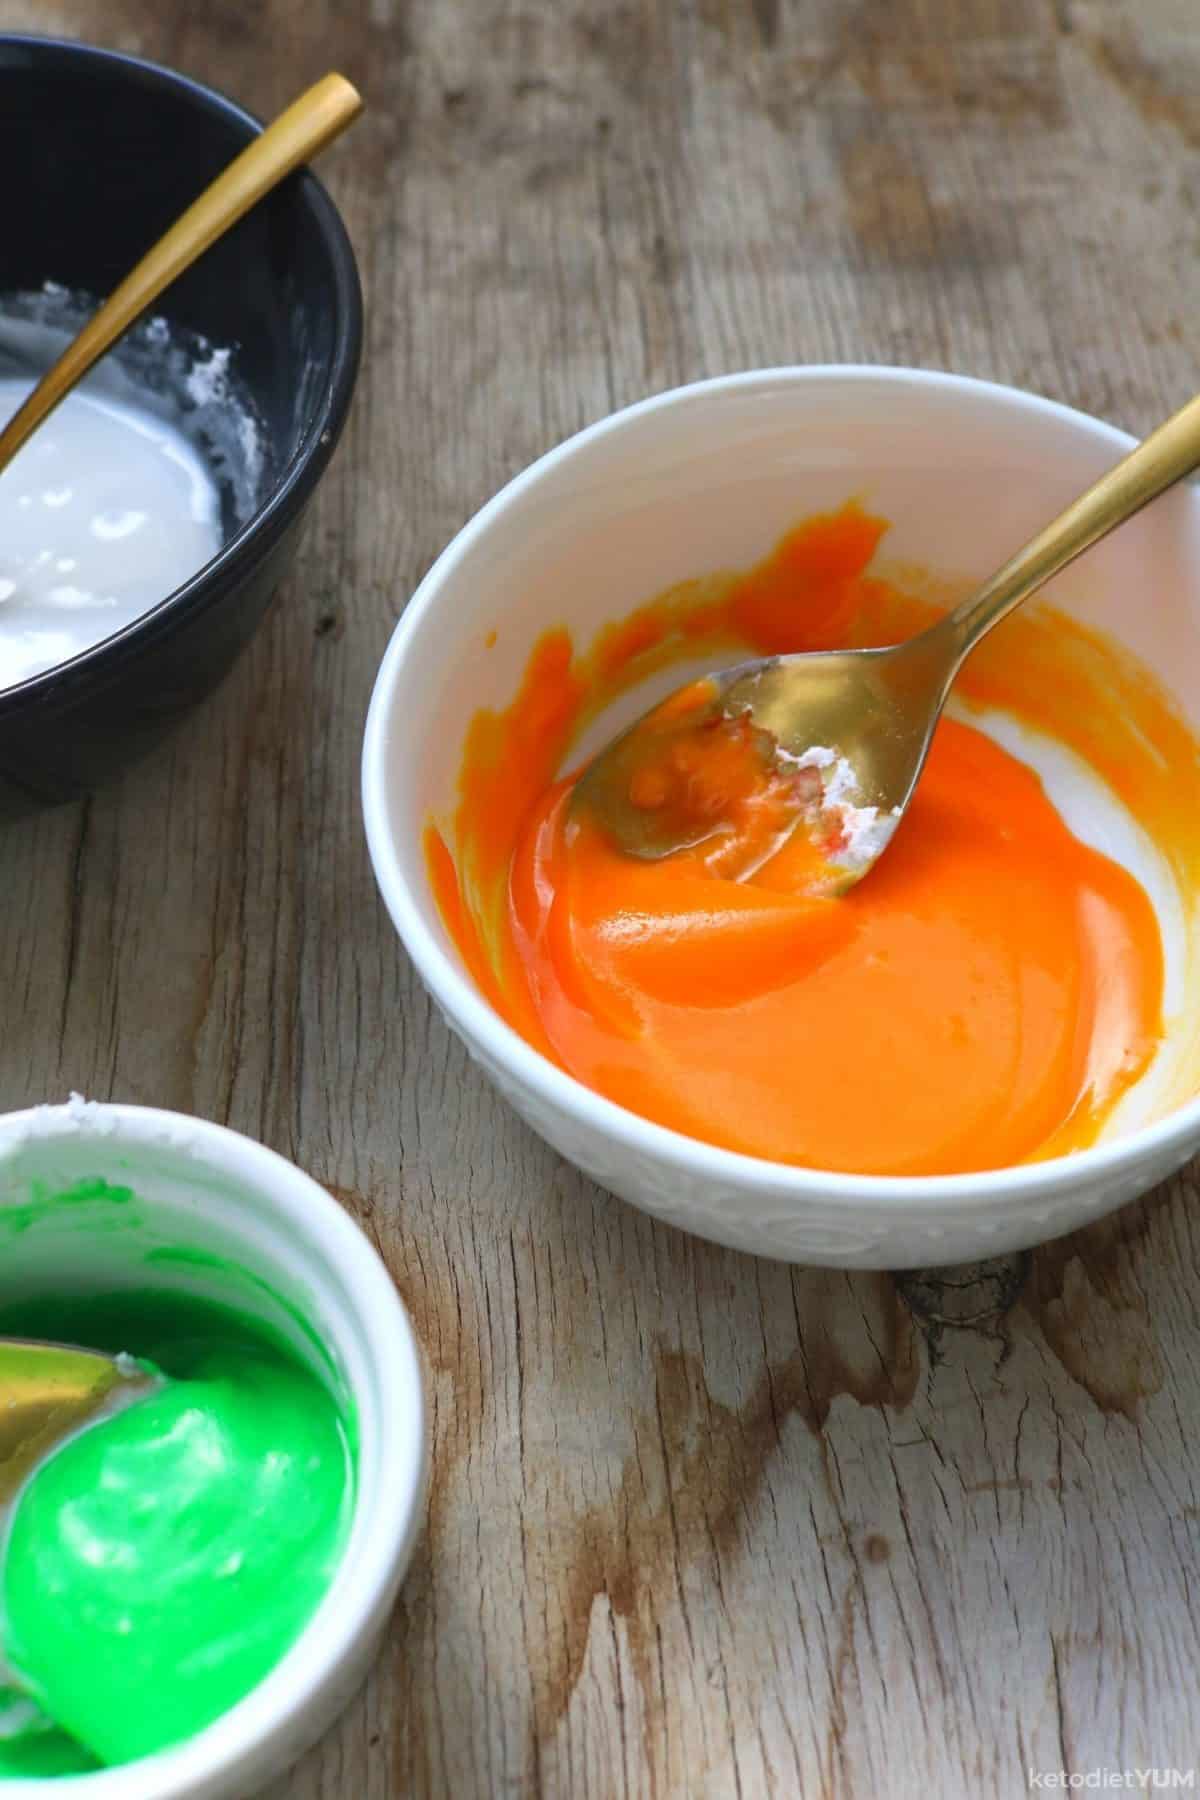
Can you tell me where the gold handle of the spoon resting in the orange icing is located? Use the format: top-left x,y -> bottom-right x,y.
934,396 -> 1200,668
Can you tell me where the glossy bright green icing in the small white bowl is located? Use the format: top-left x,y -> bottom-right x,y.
0,1289 -> 354,1777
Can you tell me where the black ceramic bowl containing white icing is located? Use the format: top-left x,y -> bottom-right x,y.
0,34 -> 362,812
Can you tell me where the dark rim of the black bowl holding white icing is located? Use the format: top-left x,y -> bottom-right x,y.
0,31 -> 363,716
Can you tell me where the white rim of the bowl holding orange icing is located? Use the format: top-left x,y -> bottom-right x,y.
362,364 -> 1200,1219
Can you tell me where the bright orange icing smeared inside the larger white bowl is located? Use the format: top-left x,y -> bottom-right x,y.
426,506 -> 1200,1174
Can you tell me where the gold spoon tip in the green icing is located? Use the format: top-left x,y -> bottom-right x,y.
0,1337 -> 153,1505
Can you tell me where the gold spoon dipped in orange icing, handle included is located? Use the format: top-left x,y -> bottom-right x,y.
572,396 -> 1200,889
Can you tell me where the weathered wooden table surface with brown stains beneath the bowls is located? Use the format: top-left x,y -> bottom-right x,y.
0,0 -> 1200,1800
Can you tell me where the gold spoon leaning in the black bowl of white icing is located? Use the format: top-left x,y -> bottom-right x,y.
0,76 -> 363,472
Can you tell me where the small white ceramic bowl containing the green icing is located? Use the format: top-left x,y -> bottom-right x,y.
0,1102 -> 428,1800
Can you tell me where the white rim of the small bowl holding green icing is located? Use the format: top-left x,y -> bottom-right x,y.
0,1096 -> 430,1800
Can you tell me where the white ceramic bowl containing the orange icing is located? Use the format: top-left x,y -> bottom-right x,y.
363,367 -> 1200,1269
